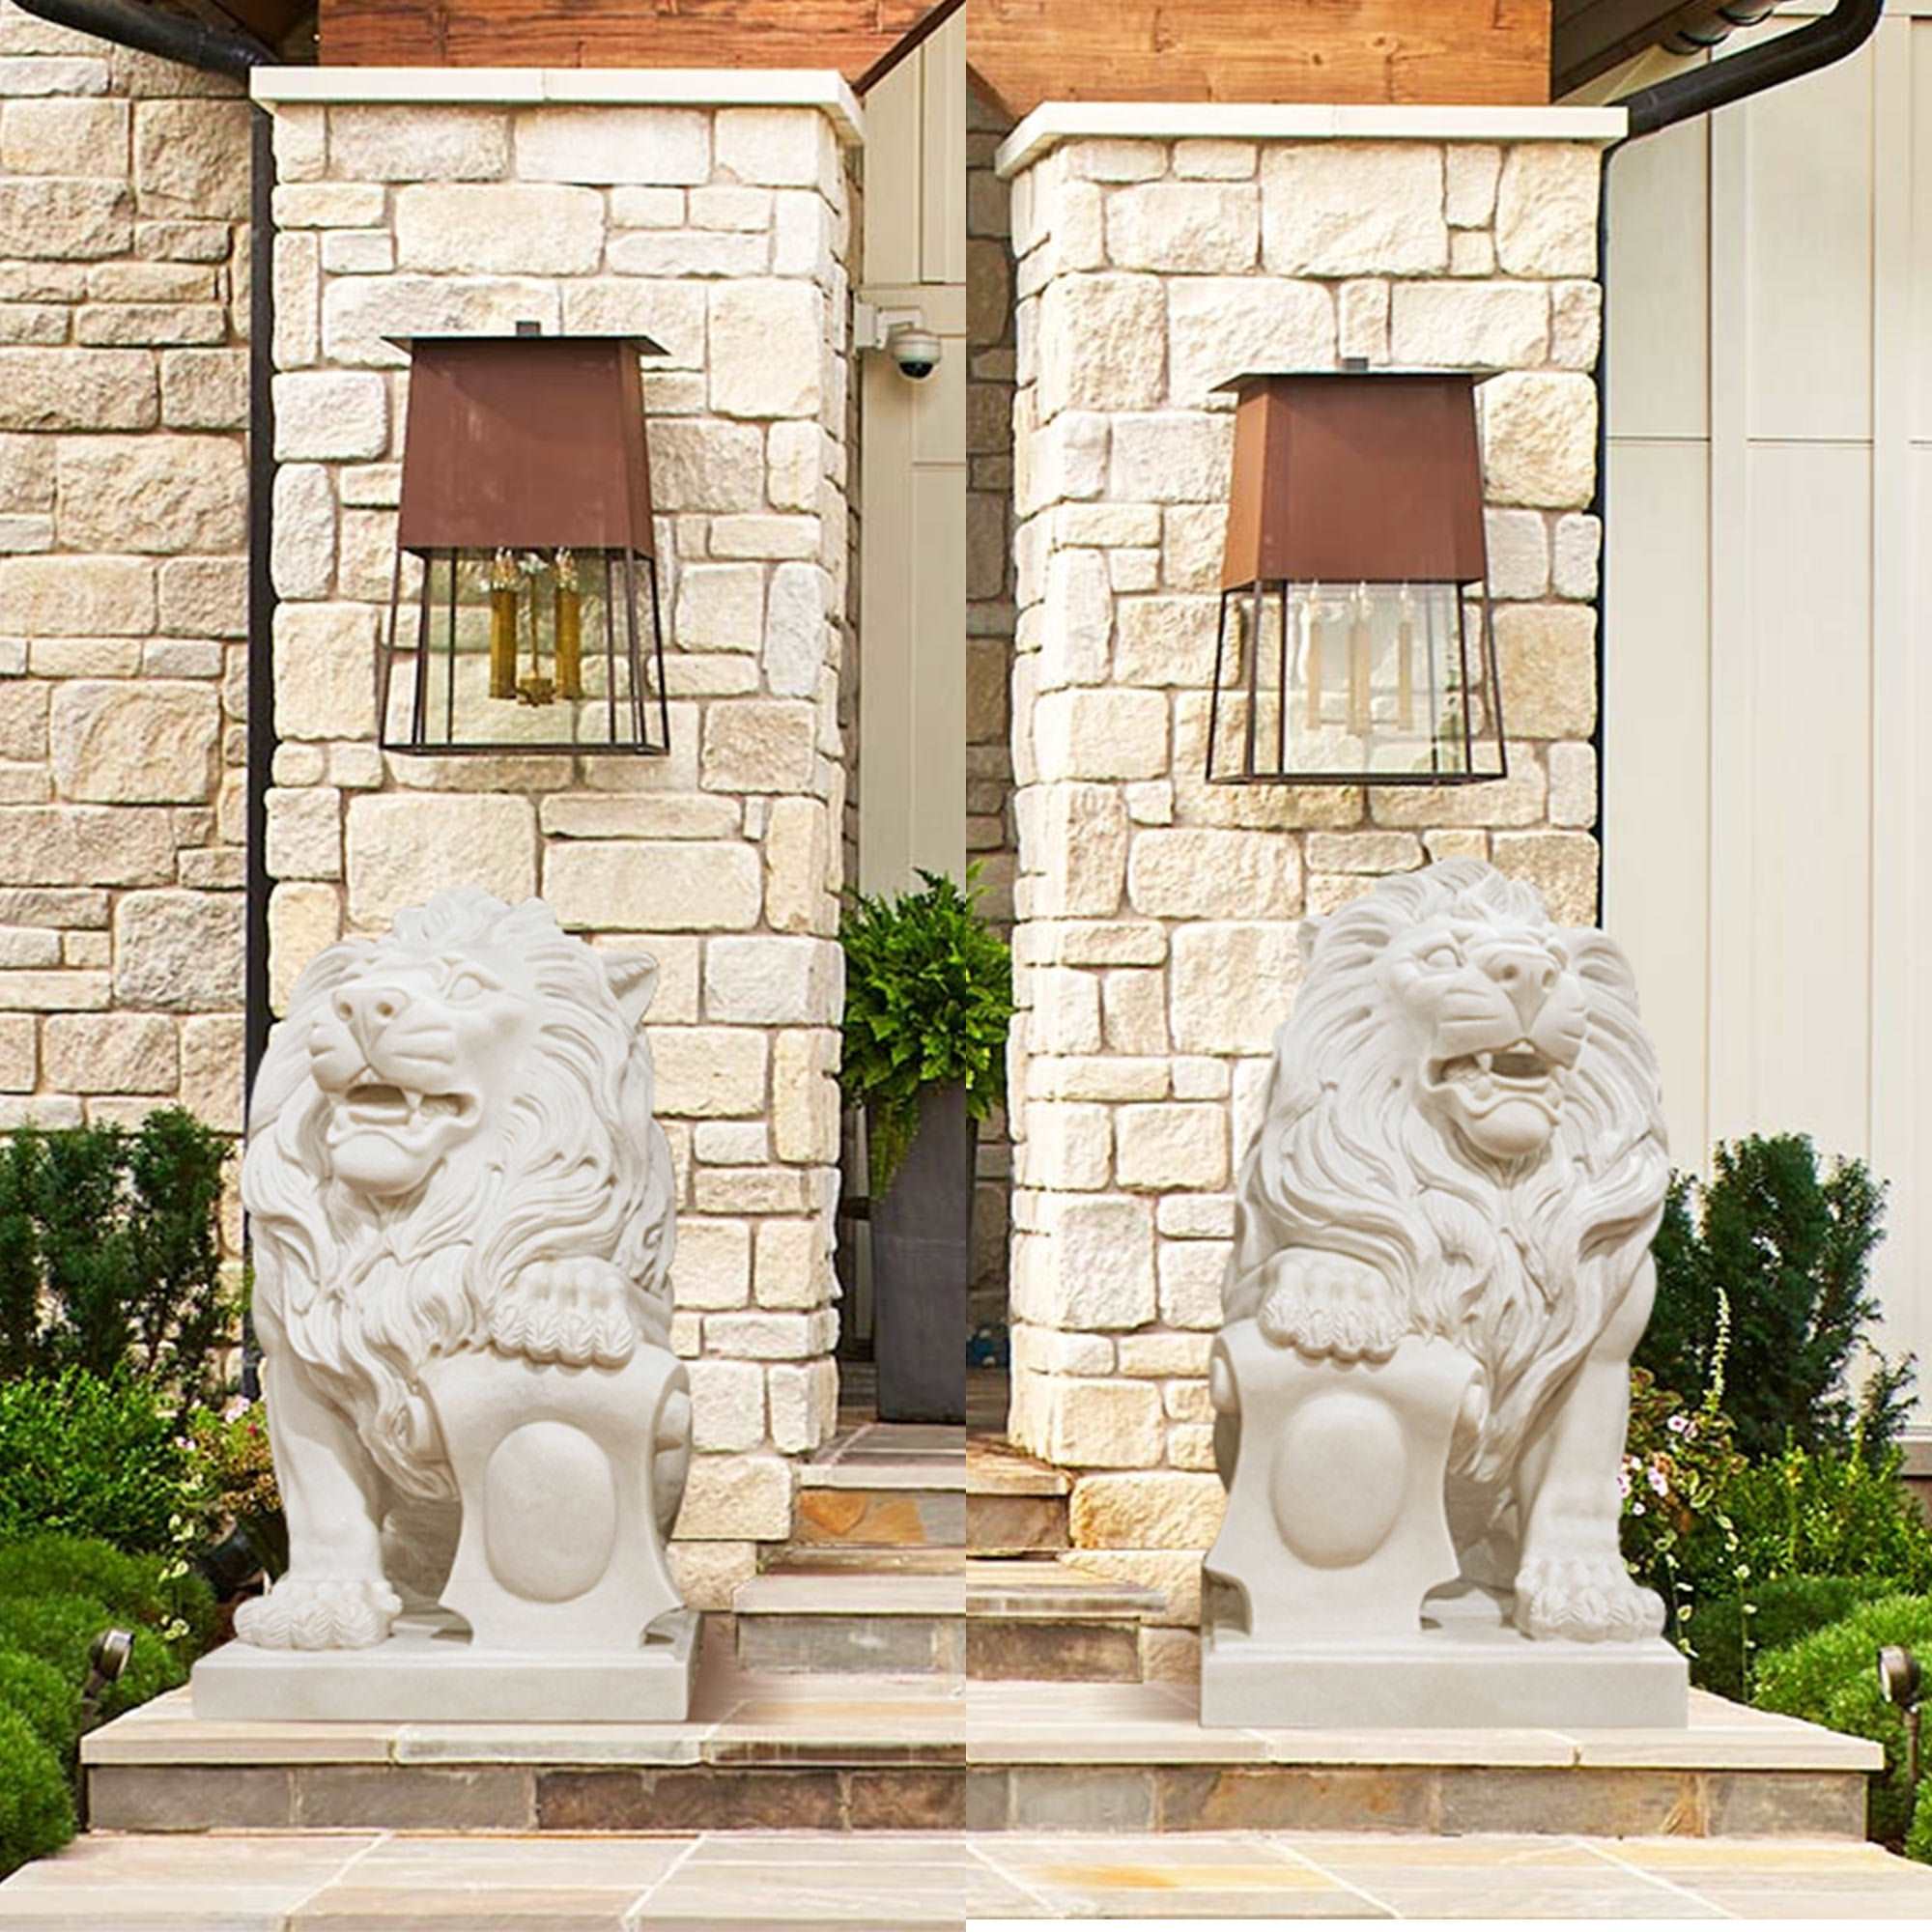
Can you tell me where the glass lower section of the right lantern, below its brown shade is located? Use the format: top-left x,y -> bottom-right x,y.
1208,582 -> 1505,784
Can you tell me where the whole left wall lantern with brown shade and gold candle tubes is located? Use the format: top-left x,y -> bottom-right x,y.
377,325 -> 670,757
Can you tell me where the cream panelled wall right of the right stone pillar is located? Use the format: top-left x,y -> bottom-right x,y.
1604,0 -> 1932,1424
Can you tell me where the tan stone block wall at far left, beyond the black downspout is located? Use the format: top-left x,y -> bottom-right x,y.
0,4 -> 251,1206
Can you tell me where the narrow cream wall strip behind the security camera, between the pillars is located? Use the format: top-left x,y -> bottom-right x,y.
858,12 -> 966,893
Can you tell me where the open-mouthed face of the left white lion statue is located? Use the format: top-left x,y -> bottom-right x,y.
309,941 -> 537,1196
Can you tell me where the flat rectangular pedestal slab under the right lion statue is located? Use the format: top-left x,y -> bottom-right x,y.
1202,1617 -> 1690,1731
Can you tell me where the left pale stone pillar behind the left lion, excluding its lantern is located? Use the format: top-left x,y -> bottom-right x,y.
259,68 -> 858,1607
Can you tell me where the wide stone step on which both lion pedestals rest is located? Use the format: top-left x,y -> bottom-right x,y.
71,1654 -> 1882,1847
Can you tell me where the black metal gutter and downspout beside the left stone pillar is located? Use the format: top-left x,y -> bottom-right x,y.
19,0 -> 282,1094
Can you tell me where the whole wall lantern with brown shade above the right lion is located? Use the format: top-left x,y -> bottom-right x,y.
1208,371 -> 1509,784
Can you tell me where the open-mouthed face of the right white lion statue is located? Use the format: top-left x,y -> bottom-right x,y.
1381,912 -> 1590,1161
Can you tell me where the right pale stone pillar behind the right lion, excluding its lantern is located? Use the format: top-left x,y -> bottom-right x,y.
1007,110 -> 1623,1667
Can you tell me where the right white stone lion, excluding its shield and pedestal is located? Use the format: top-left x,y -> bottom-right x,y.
1217,860 -> 1669,1642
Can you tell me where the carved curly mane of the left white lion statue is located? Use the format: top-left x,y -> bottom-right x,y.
242,887 -> 674,1499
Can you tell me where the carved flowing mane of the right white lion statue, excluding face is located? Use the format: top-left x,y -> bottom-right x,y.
1223,860 -> 1669,1507
